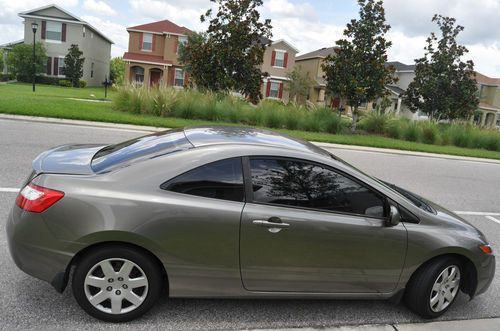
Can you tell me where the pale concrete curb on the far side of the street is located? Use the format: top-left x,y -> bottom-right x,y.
0,114 -> 500,164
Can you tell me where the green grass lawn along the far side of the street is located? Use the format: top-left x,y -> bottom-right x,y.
0,84 -> 500,159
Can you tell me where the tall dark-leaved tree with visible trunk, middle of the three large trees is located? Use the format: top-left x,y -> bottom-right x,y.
323,0 -> 394,131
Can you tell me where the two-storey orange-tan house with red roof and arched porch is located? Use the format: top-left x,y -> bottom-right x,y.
123,20 -> 190,87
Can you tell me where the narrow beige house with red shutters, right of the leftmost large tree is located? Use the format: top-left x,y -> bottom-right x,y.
260,39 -> 298,102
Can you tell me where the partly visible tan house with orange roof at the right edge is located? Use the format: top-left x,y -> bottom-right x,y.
473,71 -> 500,128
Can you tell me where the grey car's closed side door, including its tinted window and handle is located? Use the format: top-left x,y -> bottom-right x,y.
240,157 -> 406,293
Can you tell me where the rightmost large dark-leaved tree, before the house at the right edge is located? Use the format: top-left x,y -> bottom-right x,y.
403,15 -> 479,120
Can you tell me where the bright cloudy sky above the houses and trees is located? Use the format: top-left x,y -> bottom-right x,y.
0,0 -> 500,77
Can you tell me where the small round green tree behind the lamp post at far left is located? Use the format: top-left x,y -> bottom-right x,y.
7,42 -> 47,82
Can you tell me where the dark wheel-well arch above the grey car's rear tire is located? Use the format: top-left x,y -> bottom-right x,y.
60,241 -> 169,295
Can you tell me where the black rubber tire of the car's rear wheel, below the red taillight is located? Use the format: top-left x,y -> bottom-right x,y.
72,246 -> 163,323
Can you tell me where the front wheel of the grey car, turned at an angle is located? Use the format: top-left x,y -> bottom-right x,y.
405,257 -> 462,318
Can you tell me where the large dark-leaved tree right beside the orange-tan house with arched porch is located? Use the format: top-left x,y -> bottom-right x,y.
181,0 -> 272,102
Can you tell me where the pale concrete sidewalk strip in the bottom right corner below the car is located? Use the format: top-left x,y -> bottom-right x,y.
248,318 -> 500,331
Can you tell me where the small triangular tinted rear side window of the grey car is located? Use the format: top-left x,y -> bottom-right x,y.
160,158 -> 245,201
